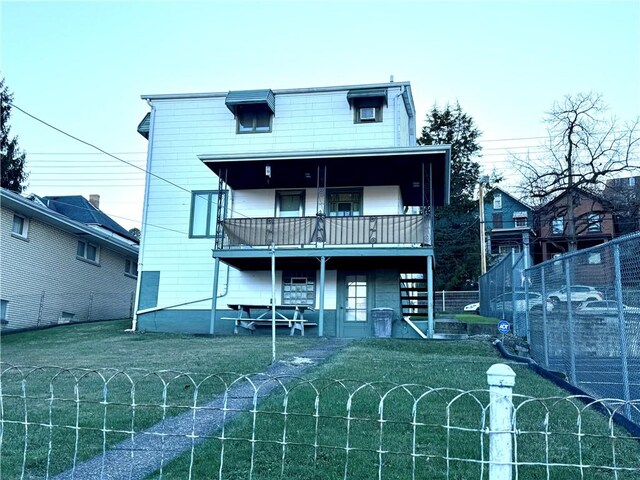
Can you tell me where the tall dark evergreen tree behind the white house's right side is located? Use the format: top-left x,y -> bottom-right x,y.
418,102 -> 482,290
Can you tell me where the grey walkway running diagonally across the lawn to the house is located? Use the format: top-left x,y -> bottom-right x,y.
54,339 -> 348,480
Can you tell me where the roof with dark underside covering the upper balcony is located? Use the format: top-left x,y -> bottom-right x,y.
199,145 -> 450,206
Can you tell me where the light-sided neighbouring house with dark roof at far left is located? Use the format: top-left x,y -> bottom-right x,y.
0,189 -> 138,330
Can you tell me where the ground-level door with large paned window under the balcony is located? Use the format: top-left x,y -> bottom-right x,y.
338,272 -> 371,338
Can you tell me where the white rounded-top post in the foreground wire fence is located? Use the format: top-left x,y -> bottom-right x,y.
487,363 -> 516,480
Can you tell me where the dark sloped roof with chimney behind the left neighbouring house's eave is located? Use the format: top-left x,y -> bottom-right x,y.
38,195 -> 139,243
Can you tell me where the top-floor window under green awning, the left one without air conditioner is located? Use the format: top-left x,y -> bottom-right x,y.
225,90 -> 276,133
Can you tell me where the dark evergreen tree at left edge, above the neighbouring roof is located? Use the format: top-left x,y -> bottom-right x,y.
0,78 -> 28,193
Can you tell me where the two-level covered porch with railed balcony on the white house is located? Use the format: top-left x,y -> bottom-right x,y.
200,146 -> 450,336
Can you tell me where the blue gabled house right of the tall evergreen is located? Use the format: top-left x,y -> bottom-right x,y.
484,187 -> 535,266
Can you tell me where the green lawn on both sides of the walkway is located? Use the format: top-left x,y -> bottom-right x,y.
0,322 -> 640,480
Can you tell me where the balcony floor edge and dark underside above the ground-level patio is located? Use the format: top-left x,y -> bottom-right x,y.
213,248 -> 433,273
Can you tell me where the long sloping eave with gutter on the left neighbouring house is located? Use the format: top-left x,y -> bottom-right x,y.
0,189 -> 139,258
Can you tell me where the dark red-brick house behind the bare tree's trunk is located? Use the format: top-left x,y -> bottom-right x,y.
536,189 -> 614,269
